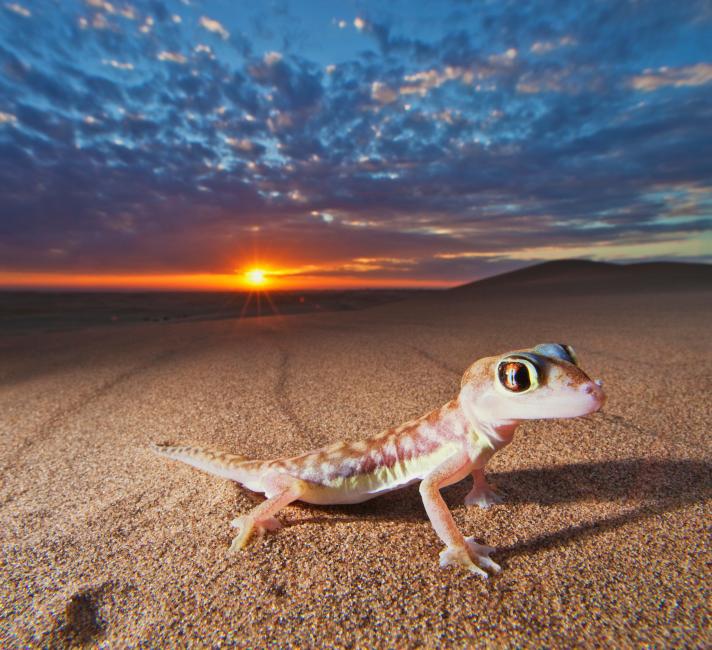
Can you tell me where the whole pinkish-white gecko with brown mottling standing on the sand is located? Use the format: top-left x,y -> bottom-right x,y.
152,343 -> 606,578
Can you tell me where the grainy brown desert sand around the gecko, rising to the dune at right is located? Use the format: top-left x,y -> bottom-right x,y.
0,263 -> 712,647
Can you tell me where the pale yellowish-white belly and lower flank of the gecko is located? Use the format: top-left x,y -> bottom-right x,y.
300,443 -> 461,505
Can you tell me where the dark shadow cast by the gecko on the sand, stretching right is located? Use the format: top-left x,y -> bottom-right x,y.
290,459 -> 712,558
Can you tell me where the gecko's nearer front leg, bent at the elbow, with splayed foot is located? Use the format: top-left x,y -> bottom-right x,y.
420,451 -> 500,578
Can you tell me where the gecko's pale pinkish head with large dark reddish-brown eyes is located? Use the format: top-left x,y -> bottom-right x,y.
460,343 -> 606,422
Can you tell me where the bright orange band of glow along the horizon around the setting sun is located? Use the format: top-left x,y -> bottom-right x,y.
0,268 -> 455,291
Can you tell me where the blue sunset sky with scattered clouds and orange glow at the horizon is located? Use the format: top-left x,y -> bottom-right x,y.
0,0 -> 712,289
